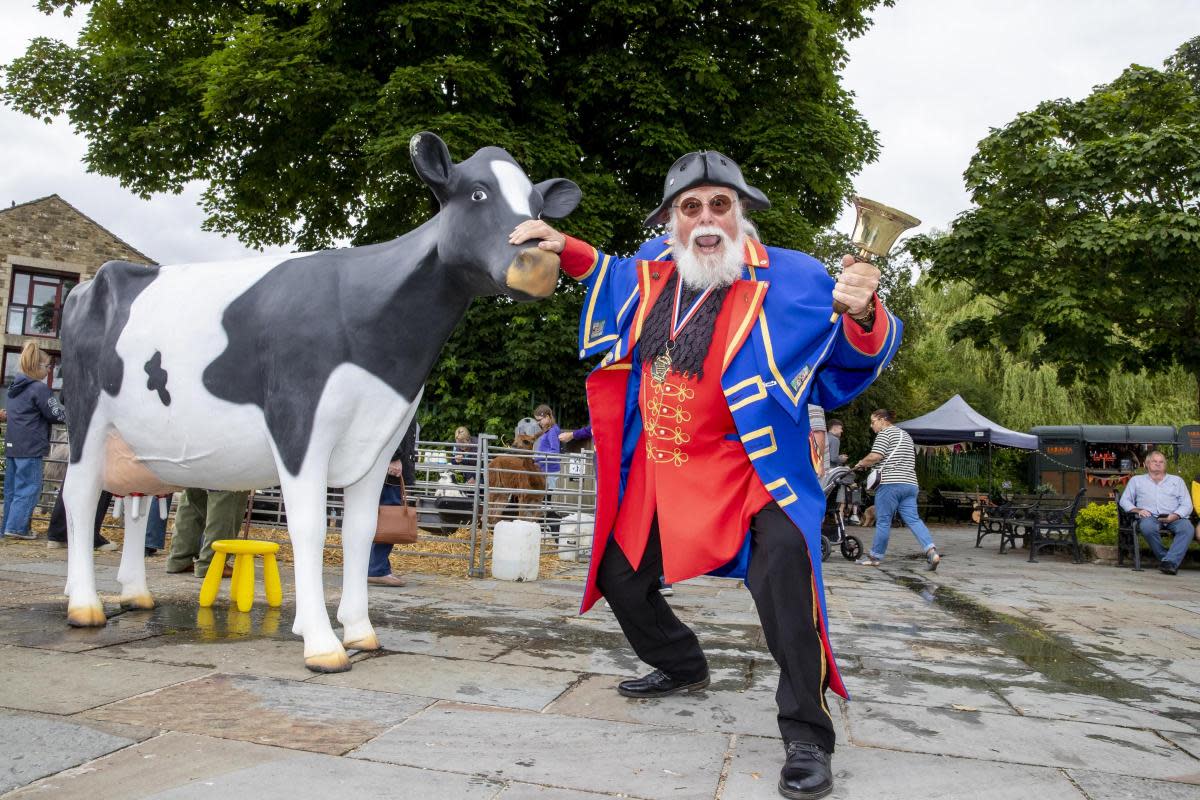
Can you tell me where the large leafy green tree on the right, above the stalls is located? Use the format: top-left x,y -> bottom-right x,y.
910,54 -> 1200,419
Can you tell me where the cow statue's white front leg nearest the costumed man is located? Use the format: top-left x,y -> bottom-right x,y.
337,470 -> 395,650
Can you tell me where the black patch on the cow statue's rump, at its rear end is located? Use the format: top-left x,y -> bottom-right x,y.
62,261 -> 158,464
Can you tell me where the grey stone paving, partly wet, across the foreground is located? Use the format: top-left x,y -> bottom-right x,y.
0,527 -> 1200,800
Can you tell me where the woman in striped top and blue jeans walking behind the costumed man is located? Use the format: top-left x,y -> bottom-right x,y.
854,408 -> 942,571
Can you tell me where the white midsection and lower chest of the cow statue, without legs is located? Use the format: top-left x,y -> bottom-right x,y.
97,255 -> 415,489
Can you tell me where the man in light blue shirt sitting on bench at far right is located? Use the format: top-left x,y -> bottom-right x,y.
1121,450 -> 1195,575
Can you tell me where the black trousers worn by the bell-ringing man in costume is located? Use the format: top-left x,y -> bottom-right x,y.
596,503 -> 835,753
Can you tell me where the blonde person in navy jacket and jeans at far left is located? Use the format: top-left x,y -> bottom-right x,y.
0,342 -> 67,539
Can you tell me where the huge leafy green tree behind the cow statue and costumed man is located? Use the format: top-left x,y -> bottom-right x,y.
4,0 -> 890,433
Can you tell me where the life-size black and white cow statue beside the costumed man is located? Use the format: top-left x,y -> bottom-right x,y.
62,133 -> 580,672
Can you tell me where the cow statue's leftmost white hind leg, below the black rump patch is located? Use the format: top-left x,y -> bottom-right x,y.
62,453 -> 108,627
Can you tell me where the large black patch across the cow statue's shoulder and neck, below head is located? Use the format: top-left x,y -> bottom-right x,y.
203,223 -> 474,475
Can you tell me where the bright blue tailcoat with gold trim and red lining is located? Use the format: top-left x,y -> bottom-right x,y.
563,236 -> 902,693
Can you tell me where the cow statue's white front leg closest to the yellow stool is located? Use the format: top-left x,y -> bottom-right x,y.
280,465 -> 350,673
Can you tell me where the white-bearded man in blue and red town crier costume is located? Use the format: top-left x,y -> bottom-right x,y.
510,151 -> 901,798
